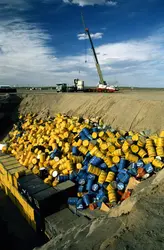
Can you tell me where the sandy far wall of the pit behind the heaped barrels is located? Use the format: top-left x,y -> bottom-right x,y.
20,91 -> 164,132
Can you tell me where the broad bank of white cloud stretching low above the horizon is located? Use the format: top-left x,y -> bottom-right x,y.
0,11 -> 164,86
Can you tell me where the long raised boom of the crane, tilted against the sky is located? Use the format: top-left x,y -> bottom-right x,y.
81,13 -> 106,85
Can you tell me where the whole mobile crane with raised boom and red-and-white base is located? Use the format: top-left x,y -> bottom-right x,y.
81,13 -> 116,92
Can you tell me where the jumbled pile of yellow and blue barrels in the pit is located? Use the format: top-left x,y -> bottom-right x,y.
2,114 -> 164,209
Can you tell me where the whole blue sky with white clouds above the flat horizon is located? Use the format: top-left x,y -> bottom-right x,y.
0,0 -> 164,87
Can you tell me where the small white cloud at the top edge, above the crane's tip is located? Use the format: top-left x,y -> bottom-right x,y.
63,0 -> 117,7
